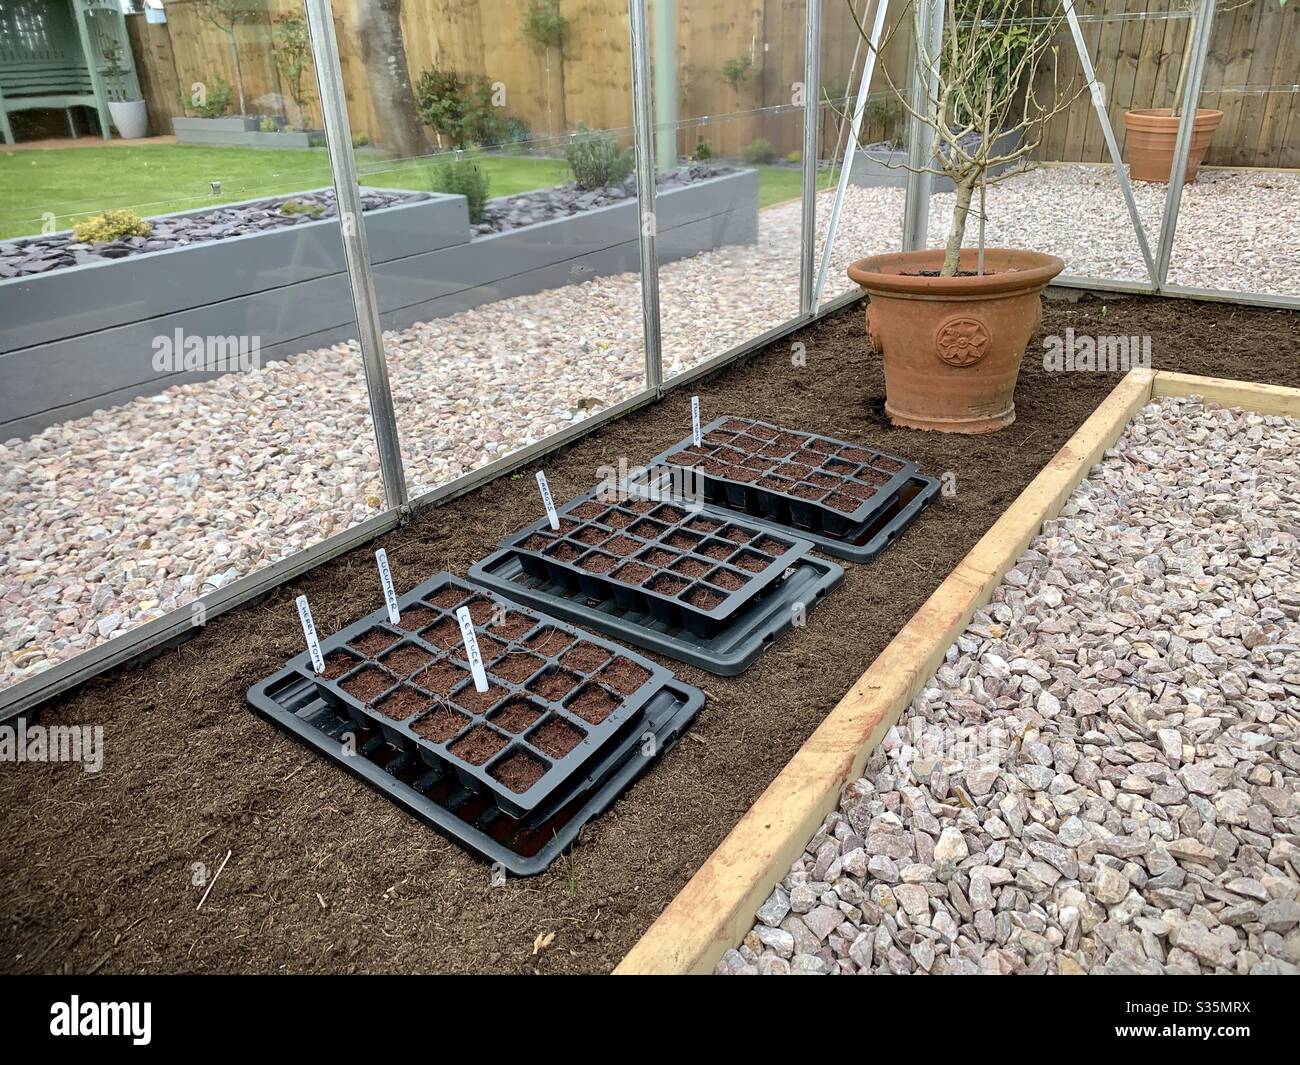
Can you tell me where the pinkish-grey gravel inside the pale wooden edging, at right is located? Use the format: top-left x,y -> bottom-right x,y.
719,399 -> 1300,974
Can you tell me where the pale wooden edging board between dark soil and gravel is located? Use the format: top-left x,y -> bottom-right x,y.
614,369 -> 1300,975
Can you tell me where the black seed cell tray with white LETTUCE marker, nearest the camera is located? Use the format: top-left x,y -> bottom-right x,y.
271,573 -> 672,818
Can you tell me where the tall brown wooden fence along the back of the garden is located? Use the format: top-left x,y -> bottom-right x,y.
119,0 -> 1300,166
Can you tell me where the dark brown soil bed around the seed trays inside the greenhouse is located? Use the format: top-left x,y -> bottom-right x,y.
0,296 -> 1300,973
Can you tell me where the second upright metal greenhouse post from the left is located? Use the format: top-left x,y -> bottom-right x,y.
628,0 -> 677,390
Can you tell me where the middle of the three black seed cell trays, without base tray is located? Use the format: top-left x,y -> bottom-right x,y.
502,488 -> 811,637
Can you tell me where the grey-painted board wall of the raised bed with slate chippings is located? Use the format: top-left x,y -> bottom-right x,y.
0,170 -> 758,440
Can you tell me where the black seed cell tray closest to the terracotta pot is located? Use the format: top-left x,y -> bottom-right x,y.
649,415 -> 917,537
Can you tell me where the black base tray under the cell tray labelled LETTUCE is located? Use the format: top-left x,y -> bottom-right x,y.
248,670 -> 705,876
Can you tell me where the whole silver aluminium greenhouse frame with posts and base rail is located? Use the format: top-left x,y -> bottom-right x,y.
0,0 -> 1300,720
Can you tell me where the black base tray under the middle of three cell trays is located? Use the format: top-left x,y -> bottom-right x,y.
469,548 -> 844,676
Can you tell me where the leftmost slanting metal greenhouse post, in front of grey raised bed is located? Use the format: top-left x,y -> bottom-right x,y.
306,0 -> 407,507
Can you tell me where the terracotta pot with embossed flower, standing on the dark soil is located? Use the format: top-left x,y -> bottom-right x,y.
849,248 -> 1065,433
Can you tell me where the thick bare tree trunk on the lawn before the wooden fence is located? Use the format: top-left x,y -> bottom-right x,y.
356,0 -> 429,159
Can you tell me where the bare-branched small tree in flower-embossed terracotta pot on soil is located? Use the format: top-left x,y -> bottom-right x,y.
849,0 -> 1083,433
